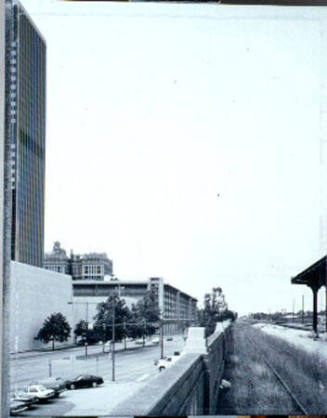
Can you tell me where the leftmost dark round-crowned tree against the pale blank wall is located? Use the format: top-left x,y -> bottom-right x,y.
35,312 -> 71,350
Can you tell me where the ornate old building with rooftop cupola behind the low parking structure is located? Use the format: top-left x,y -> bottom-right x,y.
44,241 -> 113,280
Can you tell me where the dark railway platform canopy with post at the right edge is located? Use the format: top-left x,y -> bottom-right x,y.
291,255 -> 327,334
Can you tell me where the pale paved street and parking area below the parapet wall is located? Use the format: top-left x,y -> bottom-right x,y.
11,336 -> 184,416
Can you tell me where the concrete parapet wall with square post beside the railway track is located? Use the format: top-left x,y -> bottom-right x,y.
112,323 -> 232,416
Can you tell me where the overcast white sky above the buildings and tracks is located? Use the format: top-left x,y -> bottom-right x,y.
23,0 -> 327,313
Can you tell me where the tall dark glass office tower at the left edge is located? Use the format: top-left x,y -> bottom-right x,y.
6,0 -> 46,267
